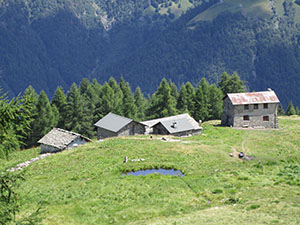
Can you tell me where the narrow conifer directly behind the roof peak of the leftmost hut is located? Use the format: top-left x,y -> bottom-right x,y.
51,87 -> 67,129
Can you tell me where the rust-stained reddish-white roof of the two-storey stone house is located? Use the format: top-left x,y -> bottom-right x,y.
227,91 -> 280,105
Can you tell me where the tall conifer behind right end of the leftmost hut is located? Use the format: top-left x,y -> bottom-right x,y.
66,83 -> 94,137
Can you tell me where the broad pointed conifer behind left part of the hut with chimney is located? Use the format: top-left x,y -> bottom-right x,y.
148,78 -> 176,118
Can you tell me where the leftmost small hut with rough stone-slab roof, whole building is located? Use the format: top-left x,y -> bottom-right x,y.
38,128 -> 91,153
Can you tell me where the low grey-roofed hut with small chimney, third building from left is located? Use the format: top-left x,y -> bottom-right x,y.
142,113 -> 202,136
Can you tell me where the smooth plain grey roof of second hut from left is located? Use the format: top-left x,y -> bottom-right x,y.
94,113 -> 133,132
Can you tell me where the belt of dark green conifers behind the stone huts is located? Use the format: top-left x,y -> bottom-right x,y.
0,72 -> 299,157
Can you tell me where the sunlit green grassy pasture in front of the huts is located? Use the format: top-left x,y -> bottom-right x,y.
0,117 -> 300,225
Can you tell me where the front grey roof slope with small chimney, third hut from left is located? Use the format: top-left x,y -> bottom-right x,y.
160,118 -> 201,134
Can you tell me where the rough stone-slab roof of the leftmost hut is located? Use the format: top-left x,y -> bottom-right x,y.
38,128 -> 91,150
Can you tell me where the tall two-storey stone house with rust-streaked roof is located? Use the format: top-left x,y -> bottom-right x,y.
222,89 -> 279,128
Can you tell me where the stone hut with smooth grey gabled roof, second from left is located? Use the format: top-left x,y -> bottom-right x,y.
95,113 -> 145,139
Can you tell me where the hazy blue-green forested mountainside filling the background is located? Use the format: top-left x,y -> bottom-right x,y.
0,0 -> 300,105
